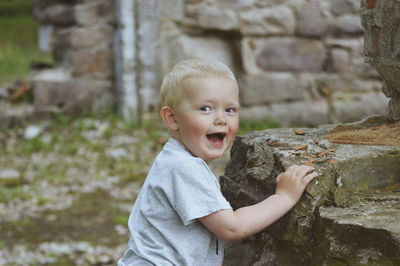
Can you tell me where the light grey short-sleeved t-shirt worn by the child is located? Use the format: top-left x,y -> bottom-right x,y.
118,138 -> 232,266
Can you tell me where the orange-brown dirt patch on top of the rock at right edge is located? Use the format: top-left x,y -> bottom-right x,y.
325,122 -> 400,146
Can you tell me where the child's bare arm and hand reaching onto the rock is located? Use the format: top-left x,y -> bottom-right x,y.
200,165 -> 317,241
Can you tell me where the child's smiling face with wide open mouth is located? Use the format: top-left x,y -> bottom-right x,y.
174,77 -> 239,163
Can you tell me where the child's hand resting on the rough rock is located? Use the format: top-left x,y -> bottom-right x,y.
276,165 -> 318,205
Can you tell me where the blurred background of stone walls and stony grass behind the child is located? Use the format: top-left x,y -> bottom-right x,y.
0,0 -> 387,265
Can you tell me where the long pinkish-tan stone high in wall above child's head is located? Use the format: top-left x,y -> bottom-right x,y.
182,6 -> 239,30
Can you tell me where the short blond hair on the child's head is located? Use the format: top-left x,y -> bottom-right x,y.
161,58 -> 236,107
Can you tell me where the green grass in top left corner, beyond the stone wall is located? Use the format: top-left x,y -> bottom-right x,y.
0,0 -> 52,85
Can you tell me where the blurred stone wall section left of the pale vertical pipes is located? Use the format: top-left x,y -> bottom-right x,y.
32,0 -> 114,116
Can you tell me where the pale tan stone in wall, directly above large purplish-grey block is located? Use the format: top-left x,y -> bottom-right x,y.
239,6 -> 296,35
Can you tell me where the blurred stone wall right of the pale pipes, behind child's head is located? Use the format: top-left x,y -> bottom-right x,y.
161,0 -> 387,126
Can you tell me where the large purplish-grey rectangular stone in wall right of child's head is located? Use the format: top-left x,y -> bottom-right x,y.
257,38 -> 326,72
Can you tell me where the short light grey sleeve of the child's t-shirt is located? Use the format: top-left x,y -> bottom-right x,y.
168,160 -> 232,225
